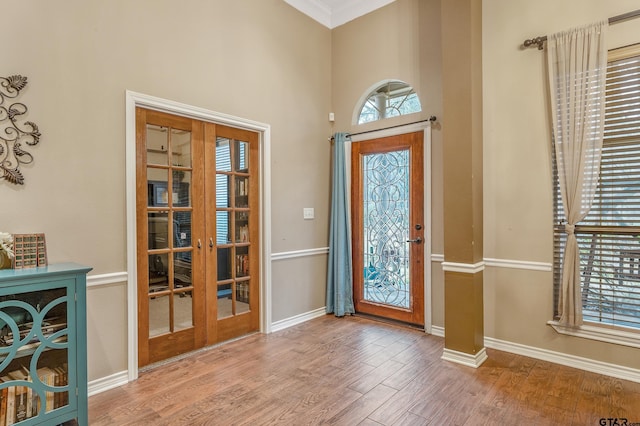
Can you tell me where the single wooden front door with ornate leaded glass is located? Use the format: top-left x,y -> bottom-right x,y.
351,132 -> 425,326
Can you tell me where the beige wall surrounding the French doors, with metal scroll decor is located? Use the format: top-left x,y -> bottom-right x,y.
0,0 -> 331,380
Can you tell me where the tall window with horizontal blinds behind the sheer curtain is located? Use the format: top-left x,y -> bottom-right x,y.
554,45 -> 640,329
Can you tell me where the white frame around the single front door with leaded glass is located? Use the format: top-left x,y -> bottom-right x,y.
345,121 -> 433,334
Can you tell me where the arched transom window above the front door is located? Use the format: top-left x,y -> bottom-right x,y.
358,80 -> 422,124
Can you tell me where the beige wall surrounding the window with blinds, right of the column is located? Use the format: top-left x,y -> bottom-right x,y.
483,0 -> 640,368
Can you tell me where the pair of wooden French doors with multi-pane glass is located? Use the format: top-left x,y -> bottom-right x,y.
136,108 -> 260,366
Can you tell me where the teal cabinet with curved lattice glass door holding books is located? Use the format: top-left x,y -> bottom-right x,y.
0,263 -> 91,426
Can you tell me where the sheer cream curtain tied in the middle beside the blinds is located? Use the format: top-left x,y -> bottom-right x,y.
547,21 -> 608,326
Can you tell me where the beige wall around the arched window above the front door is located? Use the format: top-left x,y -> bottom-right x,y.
332,0 -> 444,326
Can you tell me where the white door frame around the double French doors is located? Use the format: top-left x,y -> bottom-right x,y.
125,90 -> 272,381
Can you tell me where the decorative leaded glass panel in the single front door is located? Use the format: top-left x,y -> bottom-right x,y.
363,150 -> 411,308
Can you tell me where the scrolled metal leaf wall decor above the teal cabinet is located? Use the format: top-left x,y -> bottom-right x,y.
0,75 -> 40,185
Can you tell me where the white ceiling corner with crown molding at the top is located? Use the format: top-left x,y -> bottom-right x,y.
284,0 -> 395,28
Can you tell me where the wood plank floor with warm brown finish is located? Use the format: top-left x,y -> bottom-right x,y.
89,316 -> 640,426
